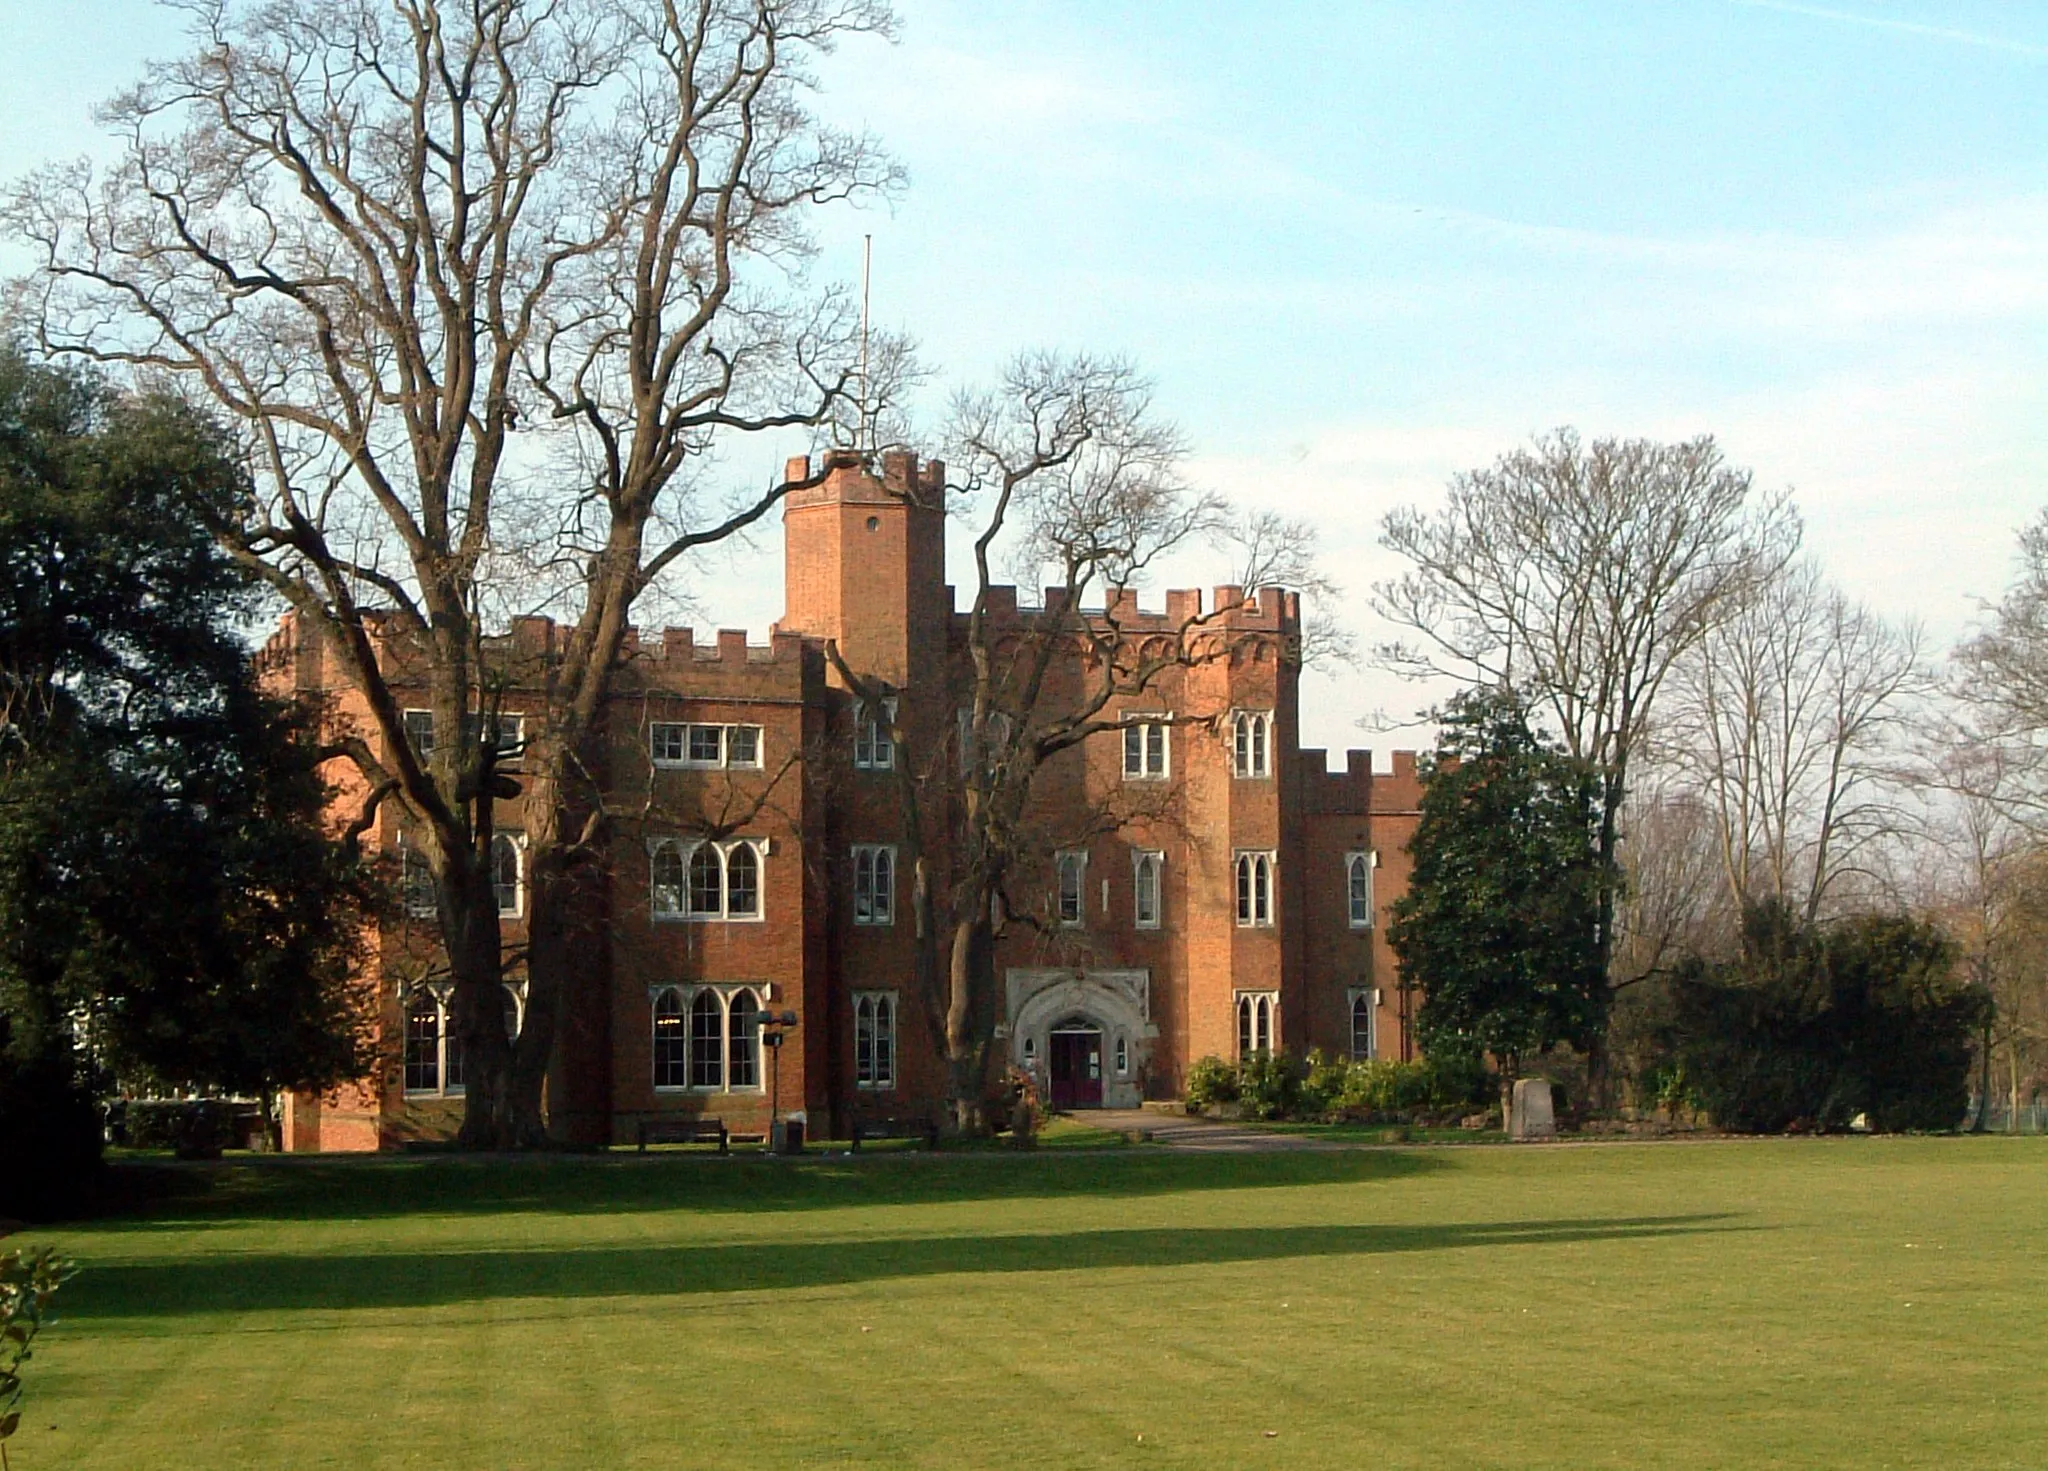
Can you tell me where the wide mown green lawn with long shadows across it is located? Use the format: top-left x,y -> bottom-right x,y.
10,1139 -> 2048,1471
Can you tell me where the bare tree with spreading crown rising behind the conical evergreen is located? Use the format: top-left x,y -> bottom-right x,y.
1372,428 -> 1798,1057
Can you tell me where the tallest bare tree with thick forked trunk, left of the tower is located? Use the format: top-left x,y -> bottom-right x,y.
4,0 -> 895,1145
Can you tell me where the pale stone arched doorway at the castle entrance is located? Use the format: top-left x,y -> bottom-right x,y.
1004,969 -> 1159,1108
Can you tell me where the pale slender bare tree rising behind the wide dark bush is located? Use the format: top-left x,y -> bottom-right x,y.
1661,561 -> 1933,924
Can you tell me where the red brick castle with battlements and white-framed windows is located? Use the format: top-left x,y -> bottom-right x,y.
266,451 -> 1419,1149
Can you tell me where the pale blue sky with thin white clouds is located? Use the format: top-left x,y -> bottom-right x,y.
0,0 -> 2048,760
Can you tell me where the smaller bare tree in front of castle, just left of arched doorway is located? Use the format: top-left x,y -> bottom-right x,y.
838,352 -> 1329,1133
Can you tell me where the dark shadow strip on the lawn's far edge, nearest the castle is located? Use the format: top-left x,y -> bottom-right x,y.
88,1149 -> 1448,1229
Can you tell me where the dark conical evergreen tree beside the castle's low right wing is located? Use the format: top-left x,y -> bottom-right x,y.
1386,688 -> 1606,1100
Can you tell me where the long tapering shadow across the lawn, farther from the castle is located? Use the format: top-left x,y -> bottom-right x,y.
66,1215 -> 1755,1323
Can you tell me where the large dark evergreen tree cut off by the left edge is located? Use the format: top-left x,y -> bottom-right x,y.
0,350 -> 375,1212
